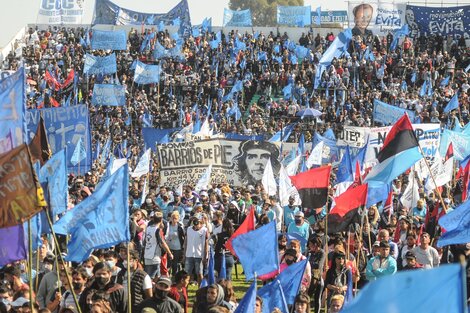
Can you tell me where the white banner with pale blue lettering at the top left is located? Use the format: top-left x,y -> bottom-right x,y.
36,0 -> 84,25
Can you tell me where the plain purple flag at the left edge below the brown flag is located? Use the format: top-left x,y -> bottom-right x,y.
0,224 -> 27,267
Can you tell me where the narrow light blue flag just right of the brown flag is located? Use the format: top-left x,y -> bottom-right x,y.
39,149 -> 68,216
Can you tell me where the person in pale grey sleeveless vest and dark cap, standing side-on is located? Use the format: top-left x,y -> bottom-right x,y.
144,211 -> 173,278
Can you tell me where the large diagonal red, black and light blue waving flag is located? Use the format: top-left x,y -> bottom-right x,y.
365,114 -> 423,184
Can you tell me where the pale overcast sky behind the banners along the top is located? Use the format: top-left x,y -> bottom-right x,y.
0,0 -> 347,47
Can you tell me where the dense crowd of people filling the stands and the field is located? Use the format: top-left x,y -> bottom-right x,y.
0,16 -> 470,313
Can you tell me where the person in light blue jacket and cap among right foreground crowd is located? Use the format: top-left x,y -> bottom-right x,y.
366,240 -> 397,281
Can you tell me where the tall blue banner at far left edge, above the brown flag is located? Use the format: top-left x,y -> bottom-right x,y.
0,68 -> 24,147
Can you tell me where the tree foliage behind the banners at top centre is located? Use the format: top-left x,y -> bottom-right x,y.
229,0 -> 304,26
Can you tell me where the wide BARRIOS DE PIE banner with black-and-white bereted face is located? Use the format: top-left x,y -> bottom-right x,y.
157,139 -> 280,187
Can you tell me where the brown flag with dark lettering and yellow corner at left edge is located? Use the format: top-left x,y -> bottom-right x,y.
0,144 -> 47,228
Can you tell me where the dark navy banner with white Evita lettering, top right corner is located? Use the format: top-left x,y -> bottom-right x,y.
405,5 -> 470,39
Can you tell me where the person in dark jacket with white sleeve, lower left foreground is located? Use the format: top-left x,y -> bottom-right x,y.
116,250 -> 153,311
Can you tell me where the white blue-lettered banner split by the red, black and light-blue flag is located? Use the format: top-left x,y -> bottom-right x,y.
364,124 -> 441,165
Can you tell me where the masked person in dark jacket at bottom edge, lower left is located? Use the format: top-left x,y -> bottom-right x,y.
78,262 -> 128,313
